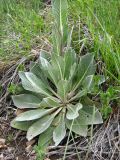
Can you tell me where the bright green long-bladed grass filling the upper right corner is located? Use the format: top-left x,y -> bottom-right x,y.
70,0 -> 120,83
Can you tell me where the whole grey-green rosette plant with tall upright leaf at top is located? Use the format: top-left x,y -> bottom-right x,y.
11,0 -> 102,145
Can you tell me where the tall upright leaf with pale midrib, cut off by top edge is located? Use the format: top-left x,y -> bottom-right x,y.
52,0 -> 68,55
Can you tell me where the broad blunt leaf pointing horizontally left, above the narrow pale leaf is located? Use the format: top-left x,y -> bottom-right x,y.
12,94 -> 41,109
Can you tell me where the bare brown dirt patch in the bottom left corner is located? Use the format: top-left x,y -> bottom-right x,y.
0,105 -> 35,160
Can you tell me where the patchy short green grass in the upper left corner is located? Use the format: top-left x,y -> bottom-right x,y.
0,0 -> 45,61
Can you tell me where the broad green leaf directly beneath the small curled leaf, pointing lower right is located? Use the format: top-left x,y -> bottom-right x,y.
66,119 -> 88,137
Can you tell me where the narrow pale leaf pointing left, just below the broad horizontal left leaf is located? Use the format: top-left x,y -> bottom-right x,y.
16,108 -> 55,121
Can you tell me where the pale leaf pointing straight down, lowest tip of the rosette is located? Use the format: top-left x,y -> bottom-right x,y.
53,115 -> 66,146
